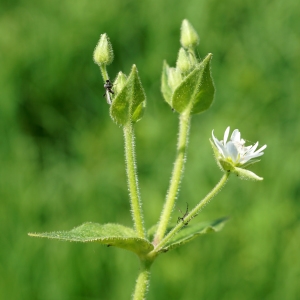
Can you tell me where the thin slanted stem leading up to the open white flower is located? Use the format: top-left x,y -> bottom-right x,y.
154,172 -> 230,252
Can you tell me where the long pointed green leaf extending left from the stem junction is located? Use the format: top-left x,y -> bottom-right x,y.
28,222 -> 153,255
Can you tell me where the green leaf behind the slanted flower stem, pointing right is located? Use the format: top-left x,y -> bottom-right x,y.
162,218 -> 228,252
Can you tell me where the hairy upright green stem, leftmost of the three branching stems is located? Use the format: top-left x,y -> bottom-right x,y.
123,122 -> 145,238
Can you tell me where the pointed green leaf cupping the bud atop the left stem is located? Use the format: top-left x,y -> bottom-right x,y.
110,65 -> 146,126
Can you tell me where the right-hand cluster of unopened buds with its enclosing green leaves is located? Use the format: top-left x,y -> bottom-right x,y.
161,20 -> 214,114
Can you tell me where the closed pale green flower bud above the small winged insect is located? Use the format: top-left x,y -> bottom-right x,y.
93,33 -> 114,66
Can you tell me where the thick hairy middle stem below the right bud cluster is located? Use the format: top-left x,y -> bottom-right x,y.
153,112 -> 191,245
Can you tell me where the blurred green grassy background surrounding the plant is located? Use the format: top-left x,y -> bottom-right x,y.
0,0 -> 300,300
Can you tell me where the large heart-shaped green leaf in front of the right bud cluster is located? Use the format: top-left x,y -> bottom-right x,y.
171,53 -> 215,114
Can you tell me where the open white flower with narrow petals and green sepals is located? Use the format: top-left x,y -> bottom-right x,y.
212,127 -> 267,180
